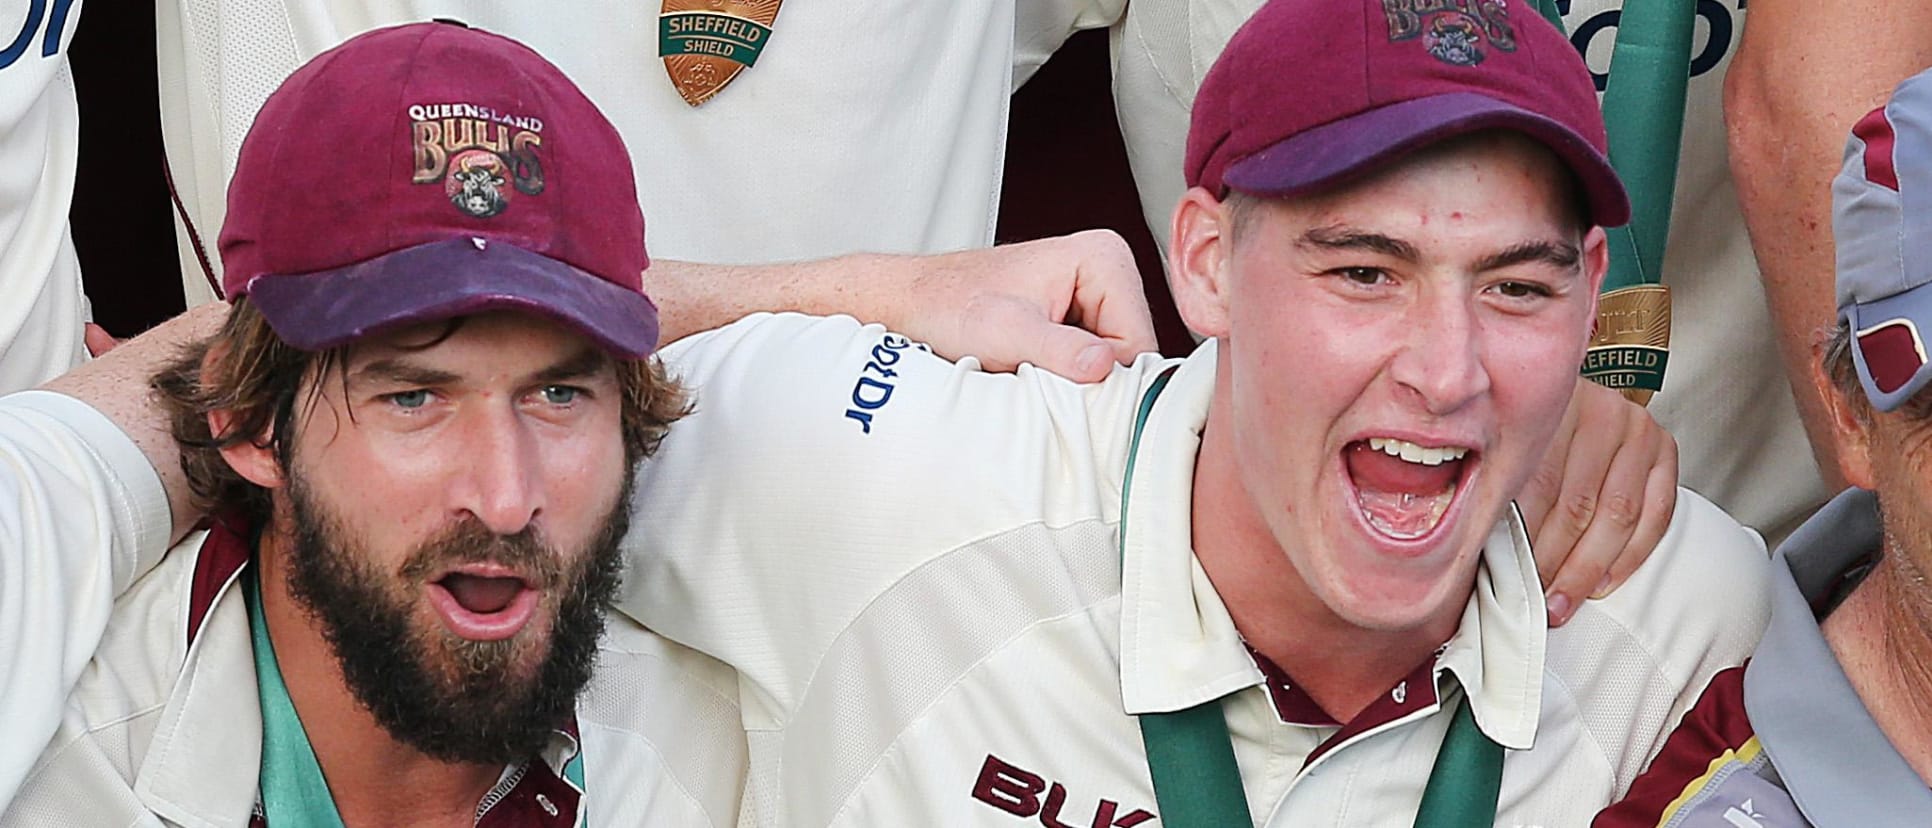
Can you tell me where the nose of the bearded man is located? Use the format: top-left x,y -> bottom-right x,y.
450,401 -> 545,535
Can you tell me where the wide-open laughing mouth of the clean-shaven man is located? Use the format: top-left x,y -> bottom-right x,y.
1341,436 -> 1474,540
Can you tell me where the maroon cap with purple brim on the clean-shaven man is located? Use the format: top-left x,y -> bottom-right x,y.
1186,0 -> 1631,226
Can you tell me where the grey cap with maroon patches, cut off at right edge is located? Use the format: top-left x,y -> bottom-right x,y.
1832,71 -> 1932,411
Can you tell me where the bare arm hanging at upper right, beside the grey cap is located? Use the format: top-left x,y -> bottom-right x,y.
1725,0 -> 1932,484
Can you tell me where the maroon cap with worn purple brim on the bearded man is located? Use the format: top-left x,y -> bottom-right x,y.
220,23 -> 657,359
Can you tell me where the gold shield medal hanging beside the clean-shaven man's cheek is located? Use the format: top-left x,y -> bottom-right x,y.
1582,284 -> 1671,405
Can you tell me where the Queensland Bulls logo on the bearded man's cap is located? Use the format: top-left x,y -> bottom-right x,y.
410,104 -> 545,218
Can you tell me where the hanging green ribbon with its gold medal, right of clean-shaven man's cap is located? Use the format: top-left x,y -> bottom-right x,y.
1576,0 -> 1696,403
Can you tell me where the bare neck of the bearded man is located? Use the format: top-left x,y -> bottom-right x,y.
257,533 -> 502,826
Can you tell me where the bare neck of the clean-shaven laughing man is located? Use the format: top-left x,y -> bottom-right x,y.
1192,405 -> 1463,722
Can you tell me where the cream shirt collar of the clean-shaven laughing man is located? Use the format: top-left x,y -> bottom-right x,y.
1121,340 -> 1546,749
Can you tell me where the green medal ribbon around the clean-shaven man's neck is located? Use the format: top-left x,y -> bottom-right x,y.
1119,369 -> 1503,828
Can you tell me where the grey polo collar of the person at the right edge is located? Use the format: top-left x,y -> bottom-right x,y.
1745,488 -> 1932,826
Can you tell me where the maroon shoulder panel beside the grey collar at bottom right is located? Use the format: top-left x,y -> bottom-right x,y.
1590,666 -> 1756,828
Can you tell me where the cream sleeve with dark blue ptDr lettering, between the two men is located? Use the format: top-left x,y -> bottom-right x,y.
618,315 -> 1155,728
